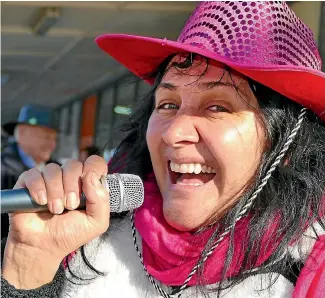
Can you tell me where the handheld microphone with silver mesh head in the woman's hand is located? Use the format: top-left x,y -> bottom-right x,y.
1,173 -> 144,213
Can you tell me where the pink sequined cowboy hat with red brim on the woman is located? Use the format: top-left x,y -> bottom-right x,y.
96,1 -> 325,121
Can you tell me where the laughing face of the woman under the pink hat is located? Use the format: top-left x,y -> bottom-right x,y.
147,57 -> 265,230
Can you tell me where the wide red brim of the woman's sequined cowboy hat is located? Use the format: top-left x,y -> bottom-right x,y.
95,34 -> 325,121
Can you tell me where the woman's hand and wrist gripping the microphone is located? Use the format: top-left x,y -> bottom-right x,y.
3,156 -> 110,288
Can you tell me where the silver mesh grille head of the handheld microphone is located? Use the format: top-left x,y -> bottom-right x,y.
102,173 -> 144,212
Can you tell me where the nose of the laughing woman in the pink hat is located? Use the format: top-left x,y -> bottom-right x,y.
162,115 -> 200,147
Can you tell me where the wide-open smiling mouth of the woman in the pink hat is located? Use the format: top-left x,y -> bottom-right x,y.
168,161 -> 216,186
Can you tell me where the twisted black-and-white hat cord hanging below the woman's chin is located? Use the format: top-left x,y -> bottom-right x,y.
131,108 -> 307,298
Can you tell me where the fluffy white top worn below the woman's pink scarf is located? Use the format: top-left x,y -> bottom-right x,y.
61,216 -> 322,298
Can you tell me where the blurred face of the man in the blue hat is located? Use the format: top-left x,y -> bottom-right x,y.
19,125 -> 57,163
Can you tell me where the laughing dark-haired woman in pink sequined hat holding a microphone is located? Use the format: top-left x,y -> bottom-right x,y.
2,2 -> 325,297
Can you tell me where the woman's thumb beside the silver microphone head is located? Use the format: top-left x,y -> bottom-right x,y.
82,171 -> 110,232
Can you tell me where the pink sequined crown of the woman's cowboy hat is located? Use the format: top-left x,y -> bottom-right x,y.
177,1 -> 321,70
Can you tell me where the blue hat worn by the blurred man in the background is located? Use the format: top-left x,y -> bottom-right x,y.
2,105 -> 58,135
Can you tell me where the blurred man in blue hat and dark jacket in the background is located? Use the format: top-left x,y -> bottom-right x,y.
1,105 -> 57,237
